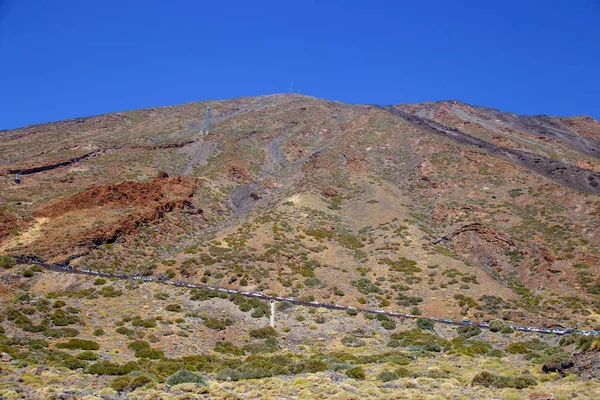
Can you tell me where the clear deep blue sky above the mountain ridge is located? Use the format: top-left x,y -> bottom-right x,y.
0,0 -> 600,129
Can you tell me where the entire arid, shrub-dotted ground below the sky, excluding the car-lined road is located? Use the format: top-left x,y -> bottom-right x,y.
0,95 -> 600,399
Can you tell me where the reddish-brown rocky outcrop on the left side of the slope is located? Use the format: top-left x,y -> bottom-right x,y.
3,172 -> 202,261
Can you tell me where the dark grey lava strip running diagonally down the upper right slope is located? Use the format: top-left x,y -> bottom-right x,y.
385,107 -> 600,194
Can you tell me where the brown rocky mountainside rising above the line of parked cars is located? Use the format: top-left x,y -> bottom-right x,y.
0,95 -> 600,327
